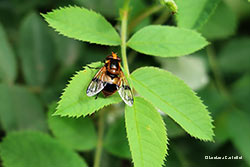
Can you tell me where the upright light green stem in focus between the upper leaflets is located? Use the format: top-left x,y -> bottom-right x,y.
121,0 -> 130,76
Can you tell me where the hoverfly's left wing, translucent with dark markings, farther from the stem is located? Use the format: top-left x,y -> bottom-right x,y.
86,67 -> 107,96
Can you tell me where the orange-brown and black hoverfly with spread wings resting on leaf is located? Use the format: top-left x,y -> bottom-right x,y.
86,52 -> 134,106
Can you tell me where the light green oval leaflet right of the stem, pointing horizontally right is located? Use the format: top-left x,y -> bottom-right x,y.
128,25 -> 208,57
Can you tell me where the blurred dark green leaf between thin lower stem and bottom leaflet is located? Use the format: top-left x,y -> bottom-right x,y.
104,117 -> 131,158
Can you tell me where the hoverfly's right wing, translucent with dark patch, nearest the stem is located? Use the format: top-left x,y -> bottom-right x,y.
117,72 -> 134,106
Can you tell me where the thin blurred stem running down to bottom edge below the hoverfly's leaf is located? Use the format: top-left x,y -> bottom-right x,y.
94,109 -> 105,167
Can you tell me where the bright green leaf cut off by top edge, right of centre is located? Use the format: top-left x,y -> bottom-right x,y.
176,0 -> 220,29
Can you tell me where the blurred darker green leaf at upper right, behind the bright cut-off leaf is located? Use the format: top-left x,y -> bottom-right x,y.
201,2 -> 237,40
